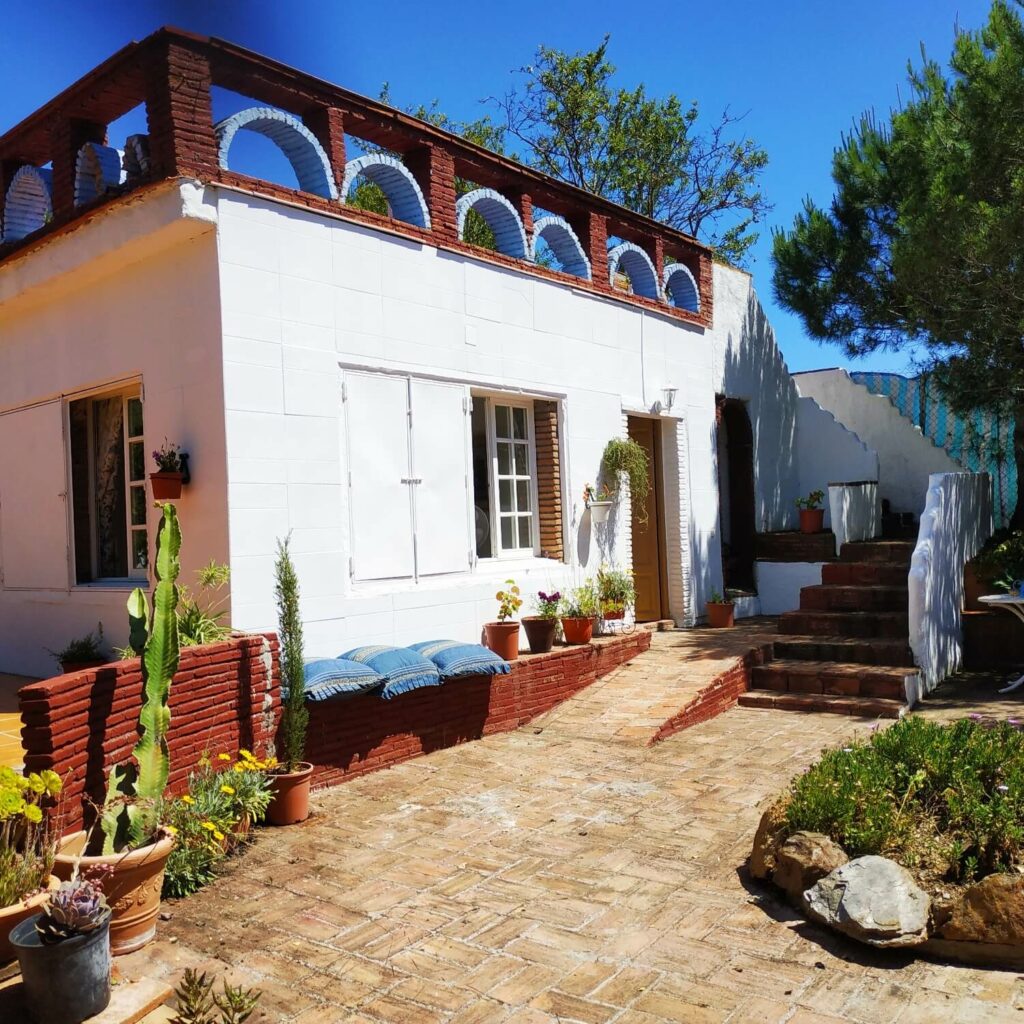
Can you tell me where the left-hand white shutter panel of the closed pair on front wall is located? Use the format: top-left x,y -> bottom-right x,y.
345,373 -> 415,580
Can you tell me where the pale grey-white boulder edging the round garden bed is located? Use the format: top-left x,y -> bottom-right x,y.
804,856 -> 931,946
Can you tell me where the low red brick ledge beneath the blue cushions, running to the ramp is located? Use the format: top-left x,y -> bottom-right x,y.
306,630 -> 650,786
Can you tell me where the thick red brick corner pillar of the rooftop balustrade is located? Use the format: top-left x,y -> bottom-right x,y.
145,41 -> 220,179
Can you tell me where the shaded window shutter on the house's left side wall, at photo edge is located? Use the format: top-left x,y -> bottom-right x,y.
0,401 -> 69,590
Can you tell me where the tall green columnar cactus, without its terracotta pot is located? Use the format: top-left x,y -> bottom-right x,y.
100,503 -> 181,855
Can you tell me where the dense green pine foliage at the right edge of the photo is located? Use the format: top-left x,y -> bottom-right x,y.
773,0 -> 1024,527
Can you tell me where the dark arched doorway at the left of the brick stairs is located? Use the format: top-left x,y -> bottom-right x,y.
716,395 -> 757,591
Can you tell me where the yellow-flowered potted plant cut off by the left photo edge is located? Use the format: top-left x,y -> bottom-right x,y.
0,766 -> 60,964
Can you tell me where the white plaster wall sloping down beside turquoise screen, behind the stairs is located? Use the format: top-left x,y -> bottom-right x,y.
795,370 -> 961,515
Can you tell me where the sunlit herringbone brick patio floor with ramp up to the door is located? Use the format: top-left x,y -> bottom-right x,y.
103,633 -> 1024,1024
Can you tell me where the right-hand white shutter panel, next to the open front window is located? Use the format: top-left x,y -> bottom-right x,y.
412,380 -> 473,575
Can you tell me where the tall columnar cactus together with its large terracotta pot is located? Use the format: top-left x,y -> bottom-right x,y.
54,504 -> 181,955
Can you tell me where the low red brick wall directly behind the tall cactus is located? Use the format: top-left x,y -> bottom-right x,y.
18,635 -> 281,831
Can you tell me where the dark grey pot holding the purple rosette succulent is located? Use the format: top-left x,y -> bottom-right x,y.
10,913 -> 111,1024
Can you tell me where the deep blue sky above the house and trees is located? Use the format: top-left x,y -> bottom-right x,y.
0,0 -> 988,371
